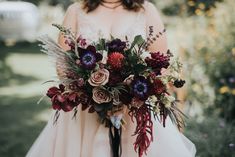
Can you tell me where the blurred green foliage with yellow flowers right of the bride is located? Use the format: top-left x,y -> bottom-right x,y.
162,0 -> 235,154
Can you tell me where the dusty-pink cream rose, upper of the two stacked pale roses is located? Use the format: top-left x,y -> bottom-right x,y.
88,68 -> 109,86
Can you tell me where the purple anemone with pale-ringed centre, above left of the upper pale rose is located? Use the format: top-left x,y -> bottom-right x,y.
79,45 -> 103,70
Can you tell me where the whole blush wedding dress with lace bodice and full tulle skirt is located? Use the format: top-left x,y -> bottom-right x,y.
26,1 -> 196,157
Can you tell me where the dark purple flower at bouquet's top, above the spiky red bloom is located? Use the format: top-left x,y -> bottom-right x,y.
107,39 -> 126,52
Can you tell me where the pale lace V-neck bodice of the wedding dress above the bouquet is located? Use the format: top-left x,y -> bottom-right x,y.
77,4 -> 147,42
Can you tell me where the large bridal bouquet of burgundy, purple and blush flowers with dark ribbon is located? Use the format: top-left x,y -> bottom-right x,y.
39,24 -> 185,157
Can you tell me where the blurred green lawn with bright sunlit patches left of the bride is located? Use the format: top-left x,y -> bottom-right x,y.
0,43 -> 54,157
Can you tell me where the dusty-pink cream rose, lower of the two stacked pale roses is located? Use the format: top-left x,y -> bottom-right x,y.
92,87 -> 112,104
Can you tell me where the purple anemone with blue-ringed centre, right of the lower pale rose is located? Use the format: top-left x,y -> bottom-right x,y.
132,76 -> 151,100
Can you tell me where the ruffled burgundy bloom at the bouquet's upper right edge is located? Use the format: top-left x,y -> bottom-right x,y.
145,52 -> 170,75
